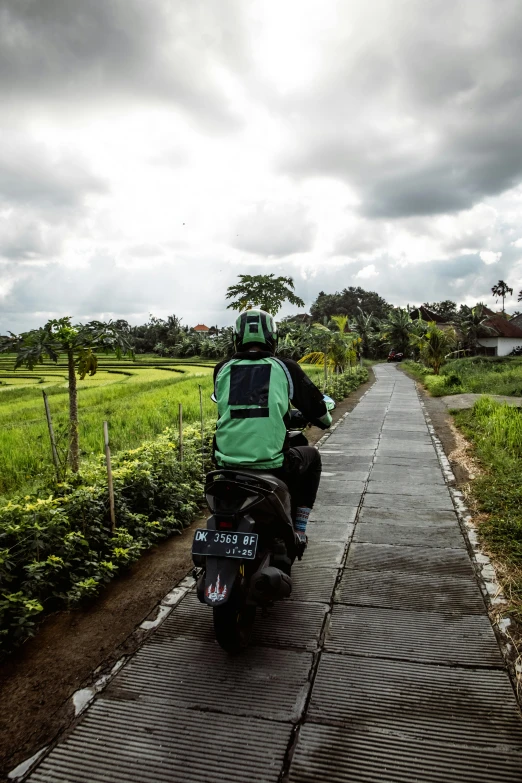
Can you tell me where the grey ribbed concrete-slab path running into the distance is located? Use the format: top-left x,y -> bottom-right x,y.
24,365 -> 522,783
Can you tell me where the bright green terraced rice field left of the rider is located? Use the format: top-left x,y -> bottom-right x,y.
0,354 -> 322,496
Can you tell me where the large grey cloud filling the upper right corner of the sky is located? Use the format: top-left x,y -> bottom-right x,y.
282,0 -> 522,218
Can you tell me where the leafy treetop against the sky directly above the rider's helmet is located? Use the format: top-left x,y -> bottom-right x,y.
226,274 -> 305,316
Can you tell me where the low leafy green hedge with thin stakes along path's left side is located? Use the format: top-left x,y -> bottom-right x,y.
0,368 -> 368,656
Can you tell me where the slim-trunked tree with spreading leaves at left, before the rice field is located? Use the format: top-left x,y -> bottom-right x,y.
0,317 -> 132,473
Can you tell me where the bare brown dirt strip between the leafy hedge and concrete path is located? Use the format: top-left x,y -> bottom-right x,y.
0,369 -> 375,781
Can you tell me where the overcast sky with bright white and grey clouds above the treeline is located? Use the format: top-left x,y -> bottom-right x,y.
0,0 -> 522,333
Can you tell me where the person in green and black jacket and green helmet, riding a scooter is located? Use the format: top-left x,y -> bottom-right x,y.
214,309 -> 332,549
